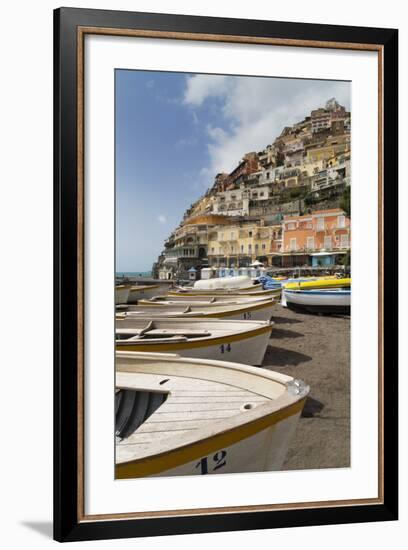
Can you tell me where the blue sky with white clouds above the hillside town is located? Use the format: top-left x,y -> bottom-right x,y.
115,69 -> 350,272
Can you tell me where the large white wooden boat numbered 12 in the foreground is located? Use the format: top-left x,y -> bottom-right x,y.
115,352 -> 309,479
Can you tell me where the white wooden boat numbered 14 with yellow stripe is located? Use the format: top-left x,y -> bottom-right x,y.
116,316 -> 272,365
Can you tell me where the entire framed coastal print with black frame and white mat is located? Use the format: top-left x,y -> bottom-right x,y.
54,8 -> 398,541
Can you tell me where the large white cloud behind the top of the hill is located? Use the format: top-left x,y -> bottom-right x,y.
183,75 -> 350,185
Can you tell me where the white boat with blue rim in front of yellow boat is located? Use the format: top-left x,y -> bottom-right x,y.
283,288 -> 351,313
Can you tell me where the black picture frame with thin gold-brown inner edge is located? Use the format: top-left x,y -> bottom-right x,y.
54,8 -> 398,541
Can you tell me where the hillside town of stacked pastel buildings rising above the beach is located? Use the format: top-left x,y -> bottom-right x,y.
153,99 -> 351,279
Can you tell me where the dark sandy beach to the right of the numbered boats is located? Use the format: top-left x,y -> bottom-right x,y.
263,305 -> 350,470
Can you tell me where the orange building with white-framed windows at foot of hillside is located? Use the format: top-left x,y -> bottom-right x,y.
282,208 -> 351,267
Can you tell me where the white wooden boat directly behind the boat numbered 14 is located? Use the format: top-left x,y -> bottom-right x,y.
117,300 -> 275,321
